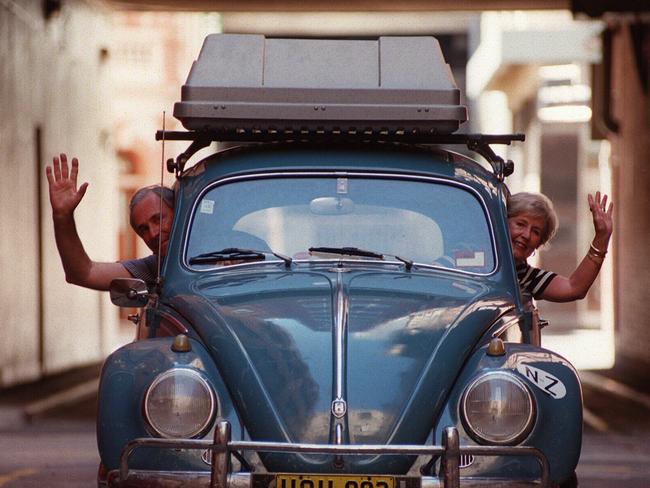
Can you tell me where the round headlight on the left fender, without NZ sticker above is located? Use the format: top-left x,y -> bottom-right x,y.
144,369 -> 216,438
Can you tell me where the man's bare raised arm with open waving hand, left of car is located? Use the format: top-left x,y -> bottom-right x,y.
45,154 -> 131,290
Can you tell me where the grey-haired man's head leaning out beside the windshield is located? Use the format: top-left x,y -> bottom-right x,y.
129,185 -> 174,256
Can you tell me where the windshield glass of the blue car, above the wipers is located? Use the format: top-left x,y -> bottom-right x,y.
185,174 -> 495,274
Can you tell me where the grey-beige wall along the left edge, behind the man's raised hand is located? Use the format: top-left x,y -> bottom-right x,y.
0,0 -> 124,387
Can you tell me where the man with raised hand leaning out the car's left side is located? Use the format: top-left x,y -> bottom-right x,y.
45,154 -> 174,290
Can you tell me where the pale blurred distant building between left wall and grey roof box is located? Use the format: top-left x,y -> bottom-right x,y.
110,11 -> 221,203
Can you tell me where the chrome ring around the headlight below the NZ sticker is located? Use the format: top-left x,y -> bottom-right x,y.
460,370 -> 537,446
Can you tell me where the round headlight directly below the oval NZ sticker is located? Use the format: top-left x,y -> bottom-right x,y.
461,371 -> 535,444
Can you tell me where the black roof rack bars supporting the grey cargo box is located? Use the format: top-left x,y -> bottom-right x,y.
156,128 -> 526,181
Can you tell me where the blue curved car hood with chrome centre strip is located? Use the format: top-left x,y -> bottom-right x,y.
167,267 -> 510,472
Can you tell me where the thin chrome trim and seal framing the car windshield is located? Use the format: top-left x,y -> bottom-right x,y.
181,170 -> 500,276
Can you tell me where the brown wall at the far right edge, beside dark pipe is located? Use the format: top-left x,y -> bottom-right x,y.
609,24 -> 650,375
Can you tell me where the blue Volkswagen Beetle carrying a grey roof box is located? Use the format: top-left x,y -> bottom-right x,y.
98,35 -> 582,488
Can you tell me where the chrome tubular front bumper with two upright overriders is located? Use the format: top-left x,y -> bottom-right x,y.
108,422 -> 551,488
